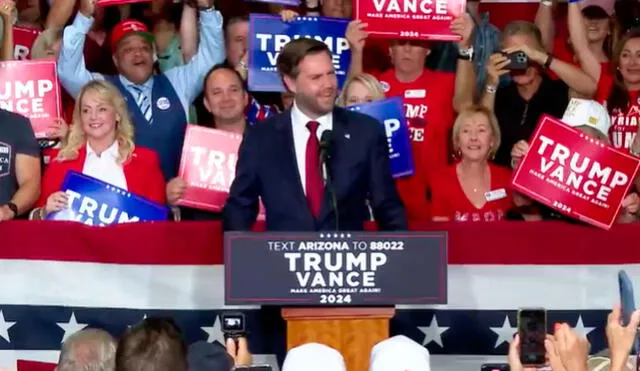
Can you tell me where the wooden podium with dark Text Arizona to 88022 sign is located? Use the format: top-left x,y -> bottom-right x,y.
224,232 -> 447,371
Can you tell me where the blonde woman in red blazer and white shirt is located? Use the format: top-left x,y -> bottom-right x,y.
33,80 -> 165,219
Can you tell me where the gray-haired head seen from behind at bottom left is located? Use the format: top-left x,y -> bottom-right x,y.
57,328 -> 116,371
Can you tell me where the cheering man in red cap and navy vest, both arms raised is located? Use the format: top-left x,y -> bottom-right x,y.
58,0 -> 224,180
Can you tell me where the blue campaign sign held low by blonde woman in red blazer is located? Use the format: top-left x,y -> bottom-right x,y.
47,171 -> 169,226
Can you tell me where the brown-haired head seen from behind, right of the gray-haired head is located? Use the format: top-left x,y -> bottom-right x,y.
116,318 -> 188,371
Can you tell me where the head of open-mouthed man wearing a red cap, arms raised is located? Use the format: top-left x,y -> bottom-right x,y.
111,19 -> 154,84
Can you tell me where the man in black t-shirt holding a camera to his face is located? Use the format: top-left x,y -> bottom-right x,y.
481,21 -> 596,166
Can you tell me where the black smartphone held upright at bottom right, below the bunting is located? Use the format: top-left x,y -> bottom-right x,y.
518,308 -> 547,366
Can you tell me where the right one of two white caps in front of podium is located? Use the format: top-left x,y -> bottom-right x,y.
369,335 -> 431,371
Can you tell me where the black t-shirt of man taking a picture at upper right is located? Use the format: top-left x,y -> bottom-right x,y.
494,75 -> 569,167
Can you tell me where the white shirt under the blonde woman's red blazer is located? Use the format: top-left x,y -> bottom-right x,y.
82,141 -> 128,190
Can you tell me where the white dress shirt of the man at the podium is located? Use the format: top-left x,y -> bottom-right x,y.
291,102 -> 333,195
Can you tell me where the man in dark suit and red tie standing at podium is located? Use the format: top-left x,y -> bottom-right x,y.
224,38 -> 407,231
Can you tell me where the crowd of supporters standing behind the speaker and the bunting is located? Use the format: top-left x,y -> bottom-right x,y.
0,0 -> 640,227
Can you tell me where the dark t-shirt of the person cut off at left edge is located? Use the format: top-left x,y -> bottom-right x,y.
0,109 -> 40,205
